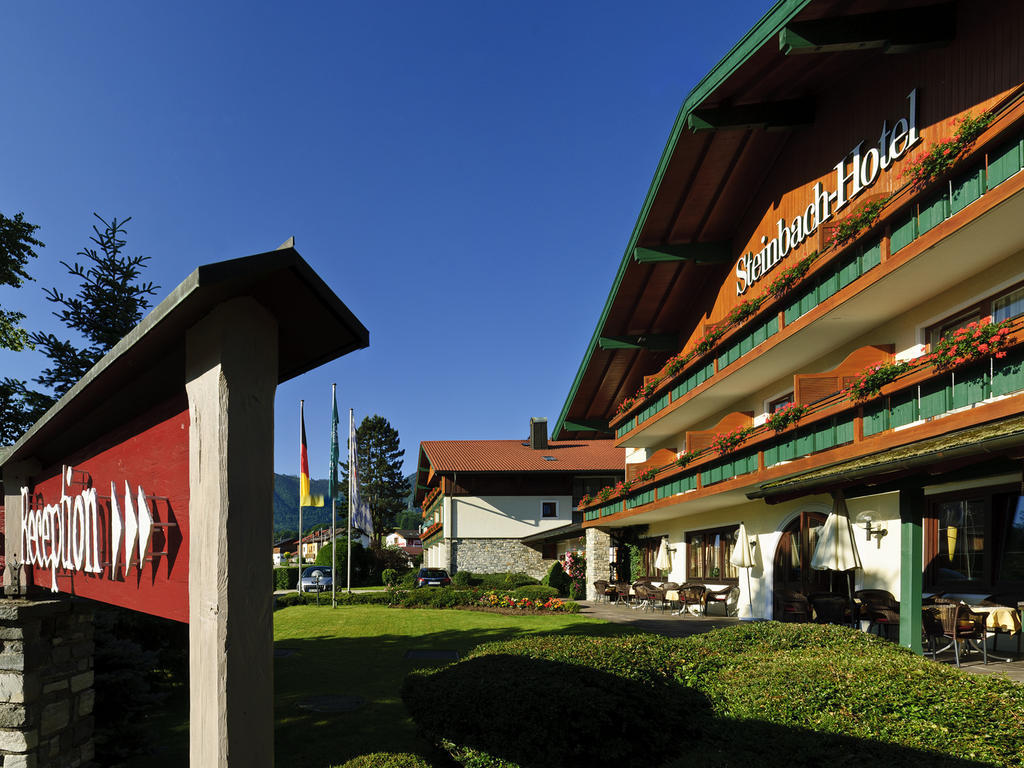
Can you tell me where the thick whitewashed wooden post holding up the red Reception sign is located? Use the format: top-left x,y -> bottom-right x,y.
185,298 -> 278,768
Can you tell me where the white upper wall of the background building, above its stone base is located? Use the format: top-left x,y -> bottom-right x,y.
444,496 -> 572,539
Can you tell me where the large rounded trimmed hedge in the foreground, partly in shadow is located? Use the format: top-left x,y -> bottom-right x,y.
402,622 -> 1024,768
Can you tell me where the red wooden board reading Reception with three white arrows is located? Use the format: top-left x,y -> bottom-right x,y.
16,402 -> 188,622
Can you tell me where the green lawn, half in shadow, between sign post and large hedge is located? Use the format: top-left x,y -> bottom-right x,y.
146,605 -> 632,768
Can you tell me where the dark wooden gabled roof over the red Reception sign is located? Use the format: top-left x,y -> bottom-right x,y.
0,247 -> 370,473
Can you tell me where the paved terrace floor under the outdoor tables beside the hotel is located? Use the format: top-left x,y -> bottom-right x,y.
580,601 -> 1024,683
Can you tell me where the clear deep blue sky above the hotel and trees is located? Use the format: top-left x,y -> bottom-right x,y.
0,0 -> 769,477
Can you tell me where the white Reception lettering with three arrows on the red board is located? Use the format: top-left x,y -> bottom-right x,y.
20,466 -> 174,592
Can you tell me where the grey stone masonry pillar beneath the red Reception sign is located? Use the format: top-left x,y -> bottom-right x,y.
0,600 -> 94,768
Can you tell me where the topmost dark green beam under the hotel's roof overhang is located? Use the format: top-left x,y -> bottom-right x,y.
778,3 -> 956,55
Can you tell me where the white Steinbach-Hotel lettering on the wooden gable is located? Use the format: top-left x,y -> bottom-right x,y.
736,88 -> 921,296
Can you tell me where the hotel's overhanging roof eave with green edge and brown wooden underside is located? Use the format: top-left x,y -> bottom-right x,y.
552,0 -> 958,439
